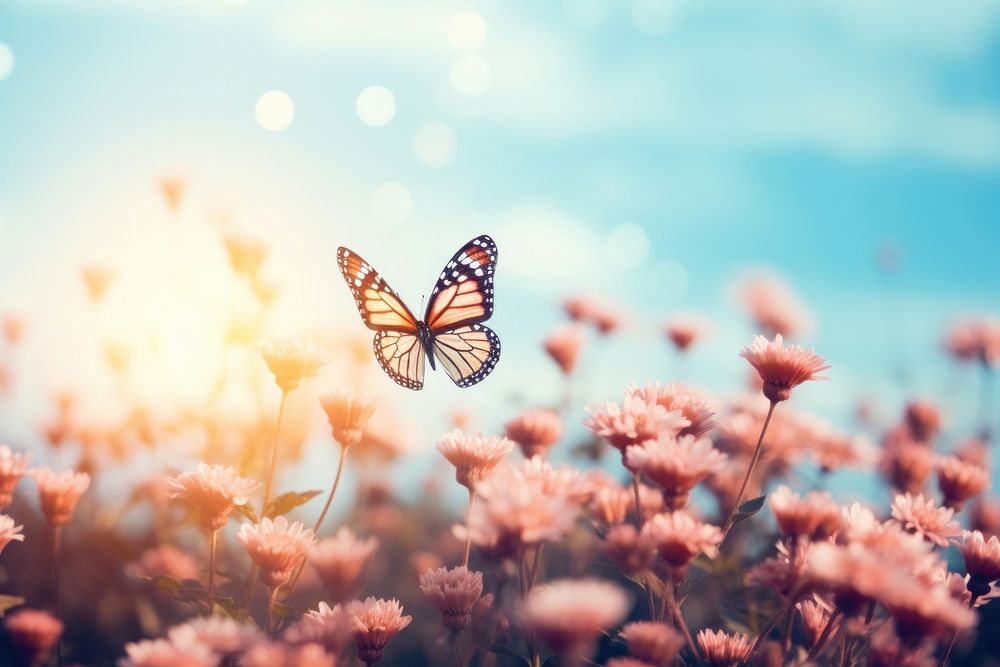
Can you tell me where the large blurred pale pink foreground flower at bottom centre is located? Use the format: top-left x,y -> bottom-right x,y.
519,579 -> 630,656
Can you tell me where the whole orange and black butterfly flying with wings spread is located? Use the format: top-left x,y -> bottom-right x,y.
337,235 -> 500,390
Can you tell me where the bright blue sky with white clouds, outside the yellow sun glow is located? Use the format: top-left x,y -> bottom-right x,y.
0,0 -> 1000,500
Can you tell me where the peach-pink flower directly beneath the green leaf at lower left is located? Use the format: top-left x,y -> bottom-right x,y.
236,516 -> 315,588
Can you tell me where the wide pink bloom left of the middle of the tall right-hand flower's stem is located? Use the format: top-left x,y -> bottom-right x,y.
625,435 -> 727,510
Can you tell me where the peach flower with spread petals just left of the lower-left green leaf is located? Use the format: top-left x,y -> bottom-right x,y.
167,463 -> 260,532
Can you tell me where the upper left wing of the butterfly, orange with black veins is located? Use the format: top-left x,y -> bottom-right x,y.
337,246 -> 417,334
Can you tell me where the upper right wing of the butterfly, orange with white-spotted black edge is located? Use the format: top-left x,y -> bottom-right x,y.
424,234 -> 499,334
